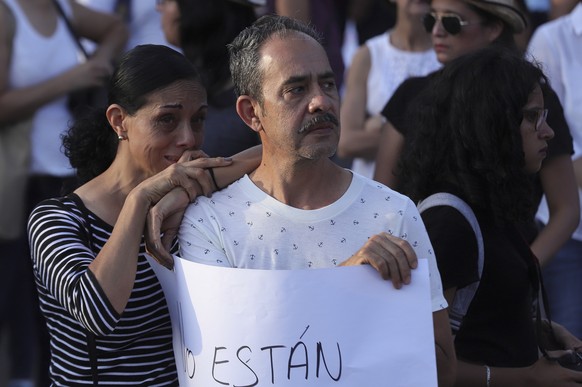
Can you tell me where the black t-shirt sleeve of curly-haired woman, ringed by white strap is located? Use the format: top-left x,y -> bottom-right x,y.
422,206 -> 479,290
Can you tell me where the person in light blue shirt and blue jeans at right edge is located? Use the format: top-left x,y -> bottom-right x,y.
528,3 -> 582,337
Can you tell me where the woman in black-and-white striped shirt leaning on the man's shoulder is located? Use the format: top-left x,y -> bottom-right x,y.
28,45 -> 259,386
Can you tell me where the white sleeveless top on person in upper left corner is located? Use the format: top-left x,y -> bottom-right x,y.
3,0 -> 80,177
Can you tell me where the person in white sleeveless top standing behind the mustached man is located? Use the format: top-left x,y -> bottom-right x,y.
338,0 -> 440,178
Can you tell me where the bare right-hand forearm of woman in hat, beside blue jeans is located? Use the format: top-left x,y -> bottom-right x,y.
531,155 -> 580,266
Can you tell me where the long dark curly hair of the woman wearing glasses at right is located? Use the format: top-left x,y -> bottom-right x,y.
400,47 -> 546,222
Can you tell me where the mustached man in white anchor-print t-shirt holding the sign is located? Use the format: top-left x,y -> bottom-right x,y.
179,16 -> 456,386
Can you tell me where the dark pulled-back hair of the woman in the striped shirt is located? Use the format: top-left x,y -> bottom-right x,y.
63,44 -> 199,184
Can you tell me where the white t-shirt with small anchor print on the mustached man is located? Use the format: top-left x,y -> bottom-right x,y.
179,174 -> 447,311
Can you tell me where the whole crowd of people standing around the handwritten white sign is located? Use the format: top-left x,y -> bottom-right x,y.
0,0 -> 582,387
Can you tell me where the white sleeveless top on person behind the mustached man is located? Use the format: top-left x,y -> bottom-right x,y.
352,31 -> 440,178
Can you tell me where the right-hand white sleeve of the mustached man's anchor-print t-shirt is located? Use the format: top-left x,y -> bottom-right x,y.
404,200 -> 448,312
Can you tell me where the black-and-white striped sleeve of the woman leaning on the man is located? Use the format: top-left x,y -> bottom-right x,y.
28,199 -> 121,335
